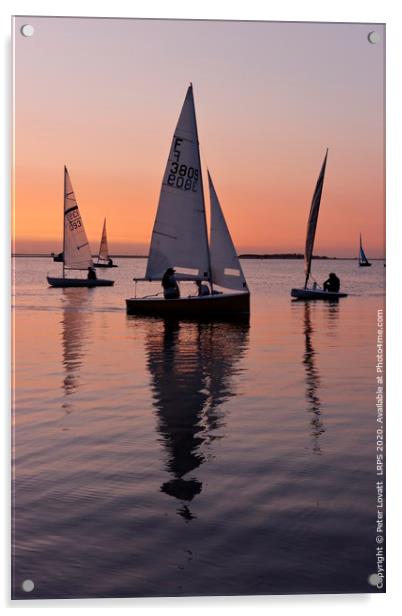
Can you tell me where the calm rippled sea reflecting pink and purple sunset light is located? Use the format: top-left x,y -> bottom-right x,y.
13,258 -> 385,598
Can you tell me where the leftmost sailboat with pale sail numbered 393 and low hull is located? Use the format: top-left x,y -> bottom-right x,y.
47,167 -> 114,287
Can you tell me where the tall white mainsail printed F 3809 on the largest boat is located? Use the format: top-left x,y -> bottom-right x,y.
145,85 -> 210,280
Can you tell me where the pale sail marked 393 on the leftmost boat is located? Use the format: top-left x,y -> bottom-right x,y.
64,167 -> 93,270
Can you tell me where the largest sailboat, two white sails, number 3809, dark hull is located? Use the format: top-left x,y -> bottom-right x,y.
126,84 -> 250,318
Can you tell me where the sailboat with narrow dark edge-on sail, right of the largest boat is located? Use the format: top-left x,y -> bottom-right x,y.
290,149 -> 347,300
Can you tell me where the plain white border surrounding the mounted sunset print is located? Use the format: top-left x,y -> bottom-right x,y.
0,0 -> 402,616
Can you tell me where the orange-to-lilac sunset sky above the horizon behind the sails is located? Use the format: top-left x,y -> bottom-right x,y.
14,17 -> 385,257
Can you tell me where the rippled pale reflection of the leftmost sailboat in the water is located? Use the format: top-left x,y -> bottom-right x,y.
61,288 -> 91,413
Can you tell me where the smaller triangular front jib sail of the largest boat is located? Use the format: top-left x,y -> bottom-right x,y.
208,171 -> 248,291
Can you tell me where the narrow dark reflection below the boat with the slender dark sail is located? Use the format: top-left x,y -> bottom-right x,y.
303,302 -> 325,454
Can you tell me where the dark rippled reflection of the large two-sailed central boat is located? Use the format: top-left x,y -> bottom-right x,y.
146,320 -> 249,520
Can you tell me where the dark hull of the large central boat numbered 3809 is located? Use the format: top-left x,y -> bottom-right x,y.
126,293 -> 250,318
